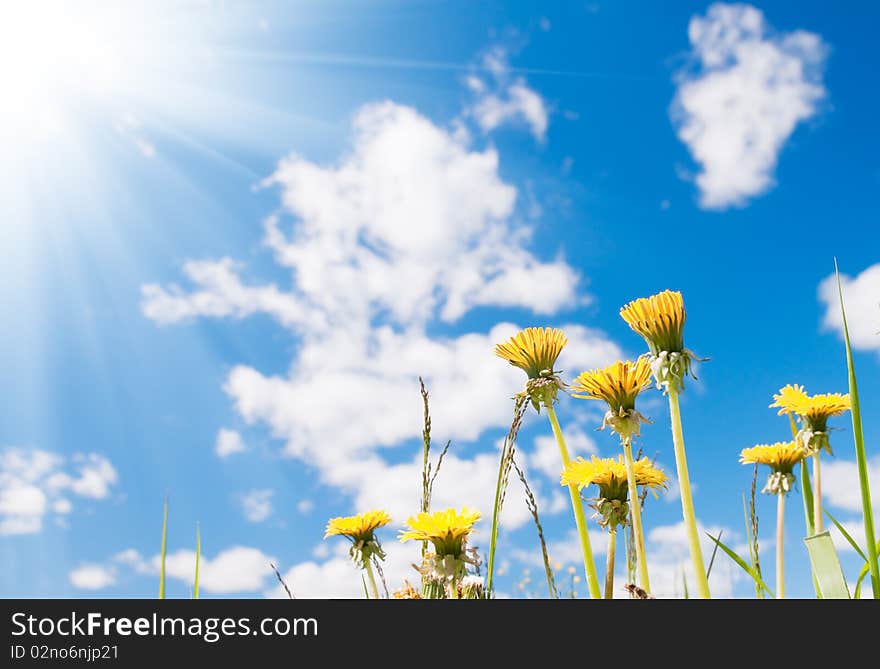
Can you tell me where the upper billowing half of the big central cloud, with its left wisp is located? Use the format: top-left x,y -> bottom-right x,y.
142,102 -> 578,332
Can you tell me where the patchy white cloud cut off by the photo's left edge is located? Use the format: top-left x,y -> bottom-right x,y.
0,448 -> 118,535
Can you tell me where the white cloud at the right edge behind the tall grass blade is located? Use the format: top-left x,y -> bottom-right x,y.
819,263 -> 880,351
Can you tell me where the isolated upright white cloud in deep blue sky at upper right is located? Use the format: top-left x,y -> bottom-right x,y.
672,3 -> 827,209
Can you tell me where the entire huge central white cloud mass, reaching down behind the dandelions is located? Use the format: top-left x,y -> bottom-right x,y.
143,95 -> 621,552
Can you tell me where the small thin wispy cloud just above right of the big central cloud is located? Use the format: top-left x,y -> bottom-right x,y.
465,47 -> 550,141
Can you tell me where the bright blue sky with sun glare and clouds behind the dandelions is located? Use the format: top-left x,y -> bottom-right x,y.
0,2 -> 880,597
